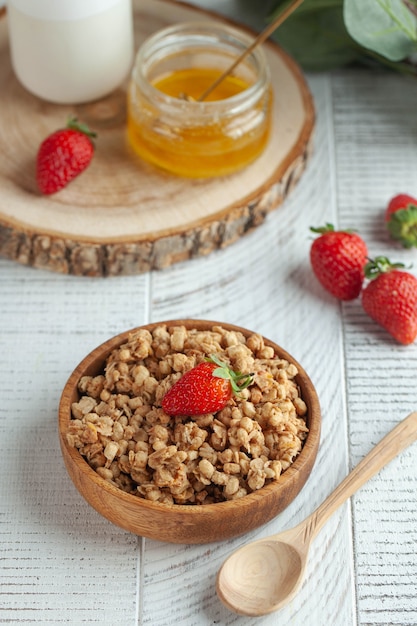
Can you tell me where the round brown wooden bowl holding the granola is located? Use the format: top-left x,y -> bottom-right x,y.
59,320 -> 321,544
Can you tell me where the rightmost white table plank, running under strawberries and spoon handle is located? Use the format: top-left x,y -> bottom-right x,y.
332,71 -> 417,626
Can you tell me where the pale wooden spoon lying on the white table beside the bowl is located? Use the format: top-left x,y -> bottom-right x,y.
216,411 -> 417,617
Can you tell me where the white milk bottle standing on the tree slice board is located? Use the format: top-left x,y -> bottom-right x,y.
7,0 -> 134,104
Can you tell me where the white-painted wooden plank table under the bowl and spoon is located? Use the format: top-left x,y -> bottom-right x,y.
0,1 -> 417,626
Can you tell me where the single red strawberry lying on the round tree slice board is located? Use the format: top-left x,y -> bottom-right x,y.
36,119 -> 96,194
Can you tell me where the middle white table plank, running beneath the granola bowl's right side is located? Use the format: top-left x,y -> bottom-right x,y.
143,77 -> 355,626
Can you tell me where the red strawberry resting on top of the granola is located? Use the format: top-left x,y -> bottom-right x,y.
162,355 -> 252,415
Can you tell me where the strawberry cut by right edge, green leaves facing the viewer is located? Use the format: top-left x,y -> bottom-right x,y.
385,193 -> 417,248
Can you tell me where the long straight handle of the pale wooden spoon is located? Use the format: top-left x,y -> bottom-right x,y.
307,411 -> 417,539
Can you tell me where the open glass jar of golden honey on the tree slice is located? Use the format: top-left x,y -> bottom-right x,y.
128,21 -> 272,178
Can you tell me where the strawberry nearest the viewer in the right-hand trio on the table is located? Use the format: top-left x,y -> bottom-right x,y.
362,257 -> 417,344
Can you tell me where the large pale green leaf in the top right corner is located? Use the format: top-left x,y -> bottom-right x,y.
343,0 -> 417,61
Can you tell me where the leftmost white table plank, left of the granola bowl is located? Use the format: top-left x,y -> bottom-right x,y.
0,259 -> 148,626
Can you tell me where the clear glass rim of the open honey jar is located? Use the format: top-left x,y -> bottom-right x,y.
132,21 -> 270,115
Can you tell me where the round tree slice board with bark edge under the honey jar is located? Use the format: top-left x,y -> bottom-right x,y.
0,0 -> 315,276
